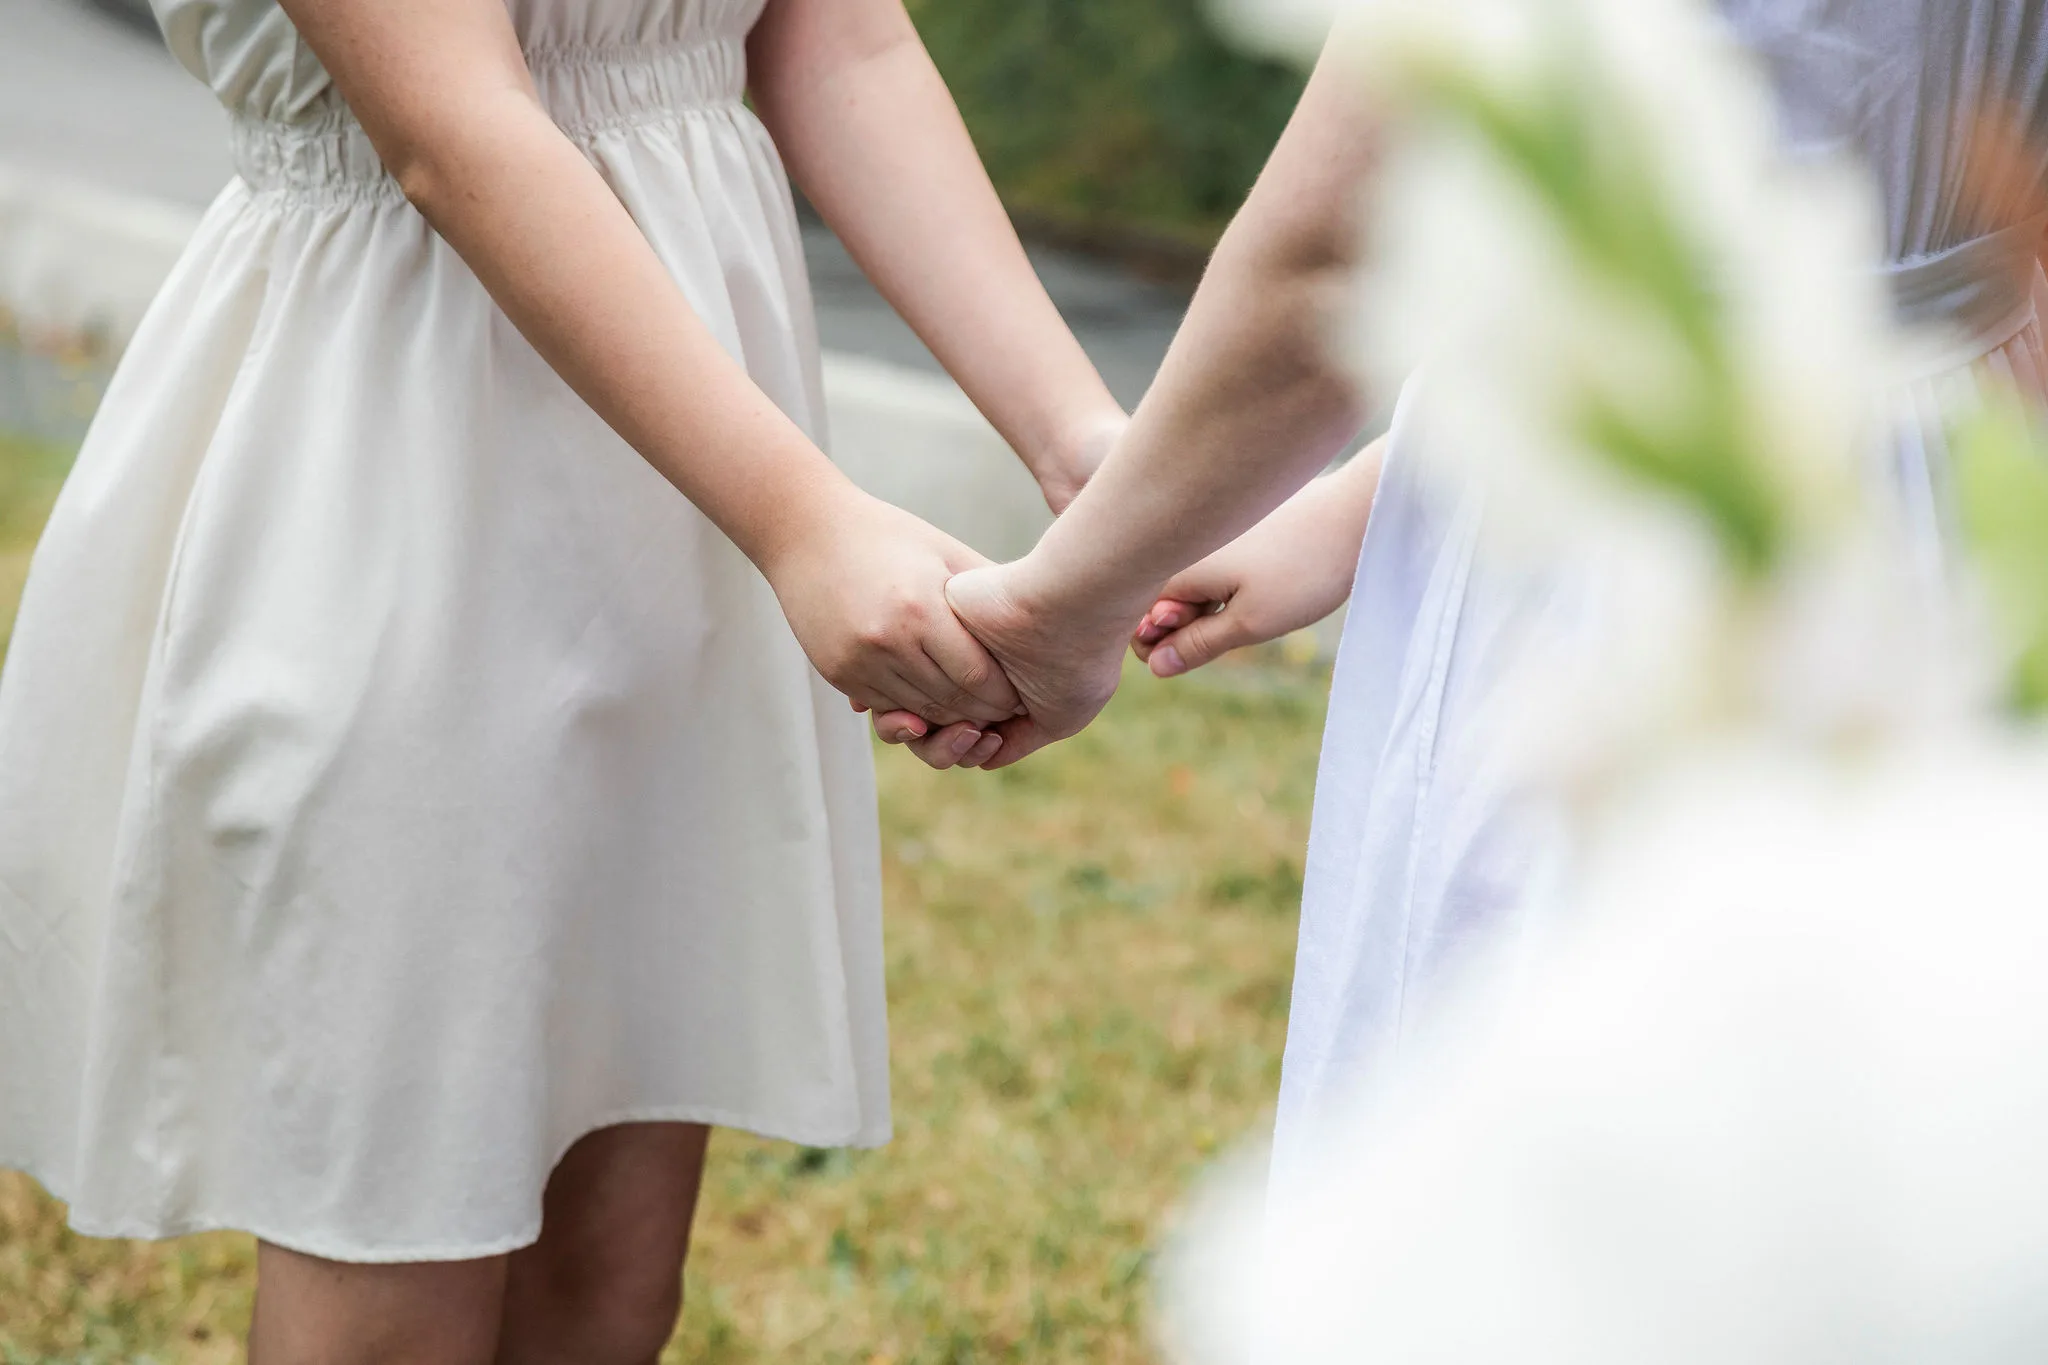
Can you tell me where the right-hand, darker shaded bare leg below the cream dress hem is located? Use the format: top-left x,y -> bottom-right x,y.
498,1124 -> 711,1365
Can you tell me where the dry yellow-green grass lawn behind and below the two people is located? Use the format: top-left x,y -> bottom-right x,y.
0,431 -> 1323,1365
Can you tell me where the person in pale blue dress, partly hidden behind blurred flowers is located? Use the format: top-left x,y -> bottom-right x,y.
877,0 -> 2048,1236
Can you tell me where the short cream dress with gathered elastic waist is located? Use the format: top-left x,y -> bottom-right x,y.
0,0 -> 889,1261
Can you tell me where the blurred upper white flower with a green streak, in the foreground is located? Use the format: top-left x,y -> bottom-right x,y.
1310,0 -> 1916,790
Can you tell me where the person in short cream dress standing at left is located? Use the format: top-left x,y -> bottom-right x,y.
0,0 -> 1124,1365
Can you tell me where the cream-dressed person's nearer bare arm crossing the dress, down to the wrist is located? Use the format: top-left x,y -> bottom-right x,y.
289,0 -> 856,565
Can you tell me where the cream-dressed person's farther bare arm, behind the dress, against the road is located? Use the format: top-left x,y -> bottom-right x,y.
748,0 -> 1124,510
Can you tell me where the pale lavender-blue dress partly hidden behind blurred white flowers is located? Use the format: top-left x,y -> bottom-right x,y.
1274,0 -> 2048,1179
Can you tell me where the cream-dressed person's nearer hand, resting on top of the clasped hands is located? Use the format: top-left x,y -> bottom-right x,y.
762,493 -> 1020,724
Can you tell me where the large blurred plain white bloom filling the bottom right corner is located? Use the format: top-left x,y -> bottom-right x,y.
1169,739 -> 2048,1365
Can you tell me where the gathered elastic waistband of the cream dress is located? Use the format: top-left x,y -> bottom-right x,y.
229,39 -> 748,194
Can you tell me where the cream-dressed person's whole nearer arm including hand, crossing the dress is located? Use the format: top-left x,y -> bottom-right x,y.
283,0 -> 1012,718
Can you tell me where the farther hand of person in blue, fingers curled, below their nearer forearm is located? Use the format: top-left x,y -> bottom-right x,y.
1130,448 -> 1378,677
